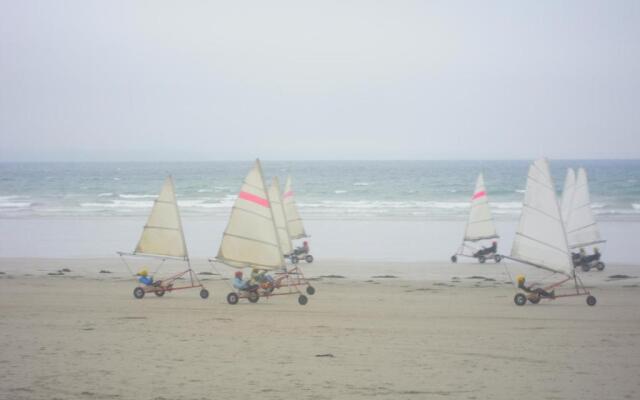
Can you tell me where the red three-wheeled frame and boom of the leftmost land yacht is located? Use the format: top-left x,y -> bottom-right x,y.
118,252 -> 209,299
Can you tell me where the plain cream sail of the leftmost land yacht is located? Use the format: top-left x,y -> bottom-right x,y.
134,176 -> 188,259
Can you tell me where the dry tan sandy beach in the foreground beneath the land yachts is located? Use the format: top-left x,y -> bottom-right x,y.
0,258 -> 640,399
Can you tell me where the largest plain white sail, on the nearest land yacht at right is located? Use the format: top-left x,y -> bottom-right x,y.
511,159 -> 573,276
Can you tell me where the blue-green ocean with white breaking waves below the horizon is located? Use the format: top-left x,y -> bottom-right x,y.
0,160 -> 640,221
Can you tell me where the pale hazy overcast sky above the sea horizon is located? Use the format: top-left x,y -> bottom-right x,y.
0,0 -> 640,161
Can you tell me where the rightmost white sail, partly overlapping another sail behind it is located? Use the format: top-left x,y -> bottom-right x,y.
565,168 -> 604,248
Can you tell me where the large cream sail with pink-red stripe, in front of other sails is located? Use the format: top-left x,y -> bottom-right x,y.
216,160 -> 284,269
